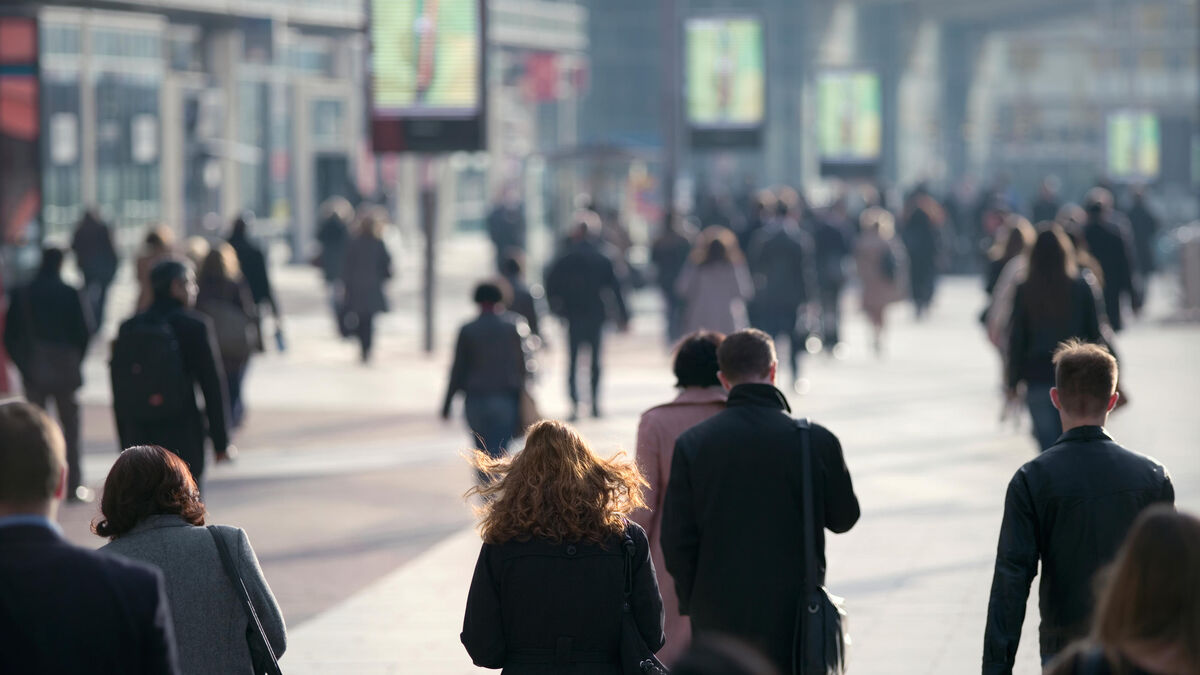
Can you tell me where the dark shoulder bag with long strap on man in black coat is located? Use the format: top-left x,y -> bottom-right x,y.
792,419 -> 850,675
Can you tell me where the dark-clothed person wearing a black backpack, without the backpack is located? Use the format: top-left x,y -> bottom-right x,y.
113,259 -> 230,489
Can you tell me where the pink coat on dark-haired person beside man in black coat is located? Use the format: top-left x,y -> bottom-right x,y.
632,387 -> 725,667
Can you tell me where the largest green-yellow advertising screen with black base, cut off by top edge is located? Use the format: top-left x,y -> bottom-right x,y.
370,0 -> 485,151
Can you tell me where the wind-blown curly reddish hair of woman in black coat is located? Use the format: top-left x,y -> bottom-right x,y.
467,419 -> 647,544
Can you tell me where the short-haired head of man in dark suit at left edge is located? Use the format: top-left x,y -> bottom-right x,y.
0,401 -> 67,518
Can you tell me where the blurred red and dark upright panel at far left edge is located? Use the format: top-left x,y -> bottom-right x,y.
0,16 -> 42,244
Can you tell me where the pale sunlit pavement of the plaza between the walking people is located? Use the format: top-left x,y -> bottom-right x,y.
51,233 -> 1200,675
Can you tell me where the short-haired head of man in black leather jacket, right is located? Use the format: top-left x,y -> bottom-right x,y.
1050,340 -> 1117,420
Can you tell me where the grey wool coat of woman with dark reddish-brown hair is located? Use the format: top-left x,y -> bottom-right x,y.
102,515 -> 287,675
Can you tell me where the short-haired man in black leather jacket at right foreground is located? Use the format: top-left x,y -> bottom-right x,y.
983,340 -> 1175,675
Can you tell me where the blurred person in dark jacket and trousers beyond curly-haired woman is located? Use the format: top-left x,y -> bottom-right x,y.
546,210 -> 629,420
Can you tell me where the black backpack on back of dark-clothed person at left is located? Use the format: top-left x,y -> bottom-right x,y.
109,317 -> 196,423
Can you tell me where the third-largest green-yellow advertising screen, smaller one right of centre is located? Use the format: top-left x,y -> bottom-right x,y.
817,70 -> 883,174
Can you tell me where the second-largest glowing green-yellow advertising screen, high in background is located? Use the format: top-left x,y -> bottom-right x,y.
684,17 -> 767,144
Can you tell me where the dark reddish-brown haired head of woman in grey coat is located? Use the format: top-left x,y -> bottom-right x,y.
91,446 -> 205,539
